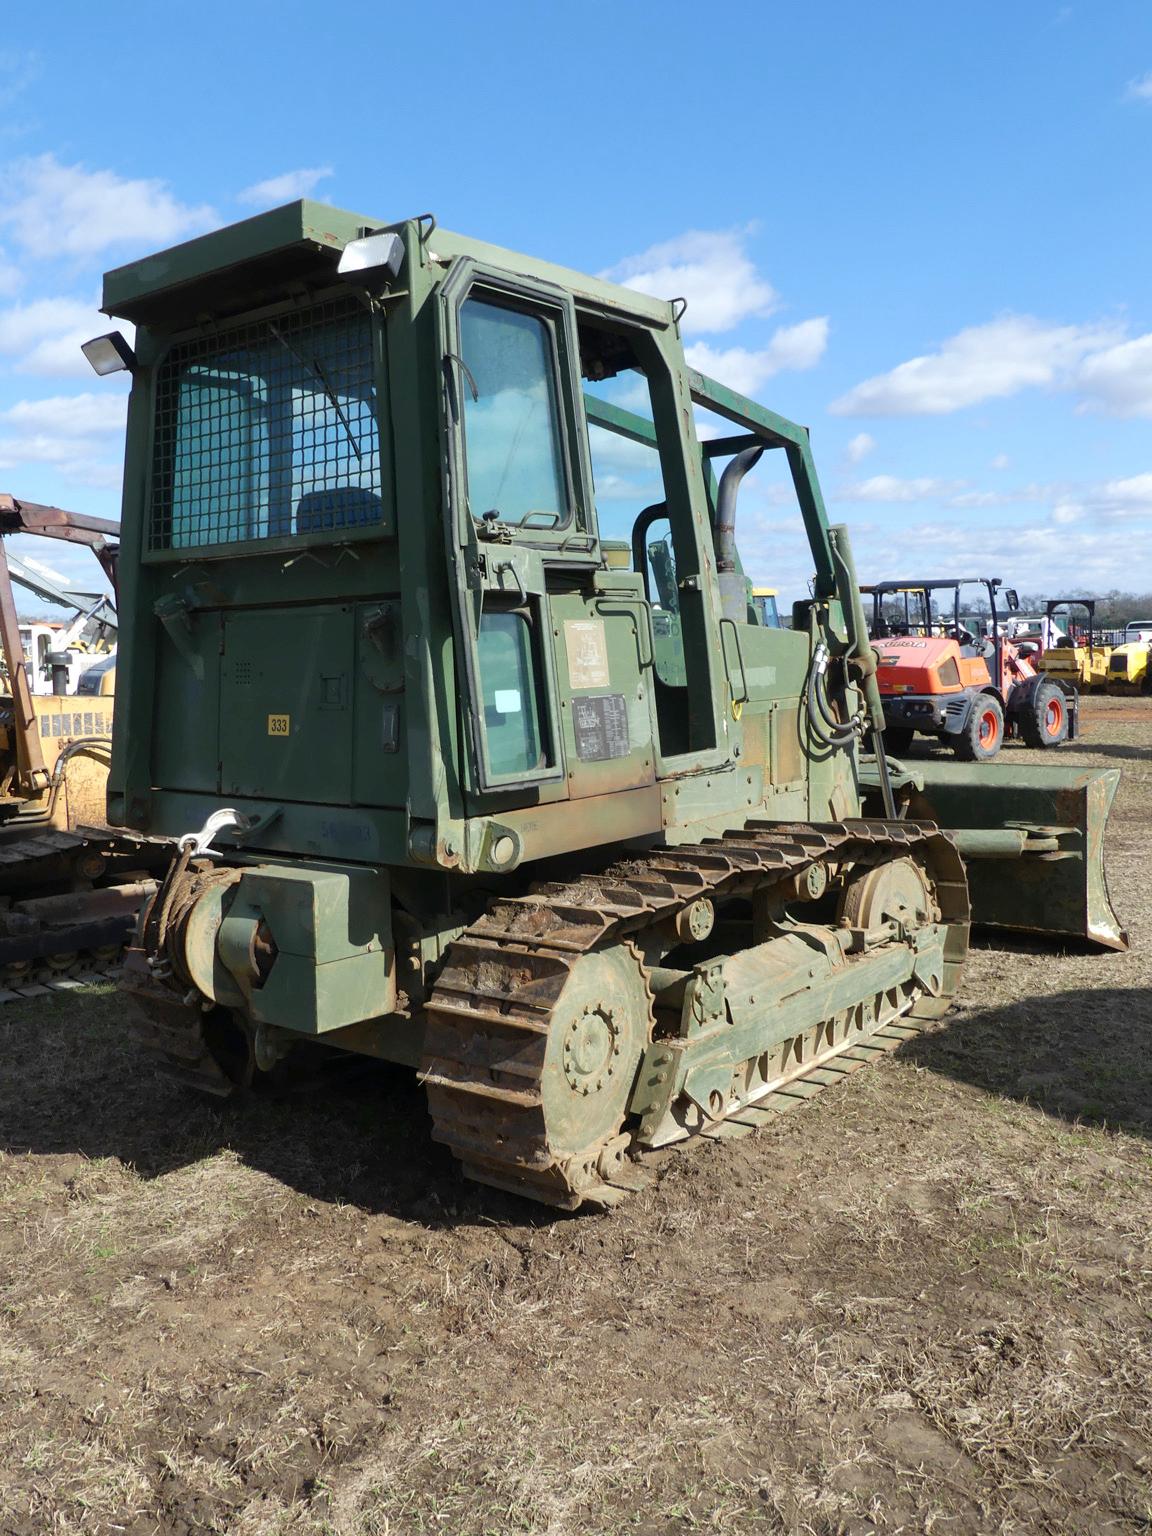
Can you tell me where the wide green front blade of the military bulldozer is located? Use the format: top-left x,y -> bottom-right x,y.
908,762 -> 1127,949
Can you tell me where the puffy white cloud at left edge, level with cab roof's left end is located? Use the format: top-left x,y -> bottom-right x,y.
0,155 -> 218,257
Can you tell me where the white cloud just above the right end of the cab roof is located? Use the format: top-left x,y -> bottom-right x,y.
601,229 -> 779,332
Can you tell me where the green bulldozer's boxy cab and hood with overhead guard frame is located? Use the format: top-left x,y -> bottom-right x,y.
94,203 -> 860,872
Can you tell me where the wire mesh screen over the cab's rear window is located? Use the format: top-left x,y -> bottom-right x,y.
149,298 -> 384,550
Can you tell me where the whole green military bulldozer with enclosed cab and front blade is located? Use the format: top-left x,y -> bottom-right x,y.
86,203 -> 1124,1209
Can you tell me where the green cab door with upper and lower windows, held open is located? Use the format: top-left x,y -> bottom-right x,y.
439,258 -> 654,814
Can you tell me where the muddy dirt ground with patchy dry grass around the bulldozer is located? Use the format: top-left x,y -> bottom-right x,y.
0,699 -> 1152,1536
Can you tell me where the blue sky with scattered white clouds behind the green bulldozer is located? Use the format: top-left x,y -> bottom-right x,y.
0,0 -> 1152,611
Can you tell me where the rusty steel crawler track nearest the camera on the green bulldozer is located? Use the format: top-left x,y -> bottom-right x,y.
421,820 -> 968,1209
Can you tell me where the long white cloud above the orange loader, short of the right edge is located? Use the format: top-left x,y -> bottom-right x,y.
829,315 -> 1123,416
